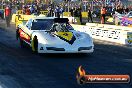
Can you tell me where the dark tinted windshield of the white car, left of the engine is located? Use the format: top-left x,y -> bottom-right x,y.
31,19 -> 53,30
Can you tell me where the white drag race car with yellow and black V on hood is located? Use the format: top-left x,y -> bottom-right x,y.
16,16 -> 94,53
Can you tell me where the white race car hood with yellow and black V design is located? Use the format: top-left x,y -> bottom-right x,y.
32,31 -> 90,45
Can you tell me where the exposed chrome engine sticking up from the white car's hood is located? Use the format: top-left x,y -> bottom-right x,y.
52,23 -> 73,32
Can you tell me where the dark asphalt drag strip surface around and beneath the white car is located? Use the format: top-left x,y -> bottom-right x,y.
0,27 -> 132,88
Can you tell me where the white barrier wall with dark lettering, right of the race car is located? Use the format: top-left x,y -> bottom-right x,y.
71,23 -> 132,45
